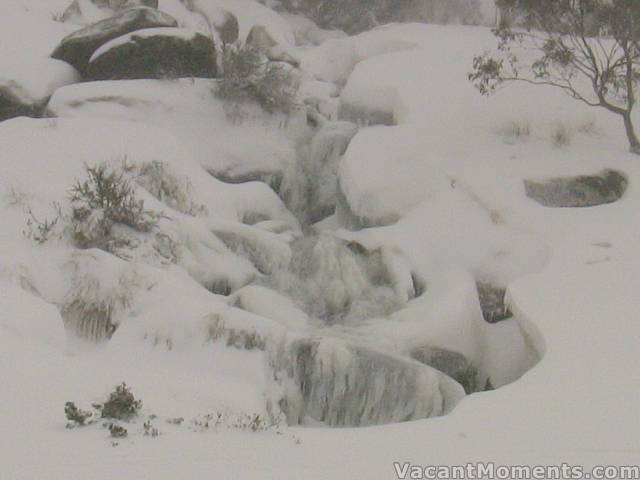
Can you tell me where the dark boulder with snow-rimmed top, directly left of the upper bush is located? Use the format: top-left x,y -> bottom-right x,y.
87,28 -> 216,80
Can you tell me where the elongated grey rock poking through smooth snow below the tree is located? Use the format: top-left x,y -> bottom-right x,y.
524,169 -> 628,208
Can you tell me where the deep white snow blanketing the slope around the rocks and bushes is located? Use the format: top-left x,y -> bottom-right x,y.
0,0 -> 640,480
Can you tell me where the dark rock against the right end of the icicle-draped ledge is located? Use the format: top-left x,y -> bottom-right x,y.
411,346 -> 478,394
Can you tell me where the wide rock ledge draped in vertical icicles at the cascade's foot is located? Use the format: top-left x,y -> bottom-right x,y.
271,338 -> 464,427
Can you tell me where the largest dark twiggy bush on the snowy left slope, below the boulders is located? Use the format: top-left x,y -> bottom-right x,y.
69,163 -> 158,251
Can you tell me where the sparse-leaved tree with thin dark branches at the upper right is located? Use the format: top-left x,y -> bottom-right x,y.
469,0 -> 640,155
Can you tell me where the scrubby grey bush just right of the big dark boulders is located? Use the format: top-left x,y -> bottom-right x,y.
215,45 -> 299,120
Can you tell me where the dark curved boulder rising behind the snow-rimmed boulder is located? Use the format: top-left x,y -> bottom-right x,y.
51,7 -> 178,74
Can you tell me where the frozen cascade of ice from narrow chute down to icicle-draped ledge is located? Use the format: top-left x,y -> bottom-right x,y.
221,115 -> 540,426
